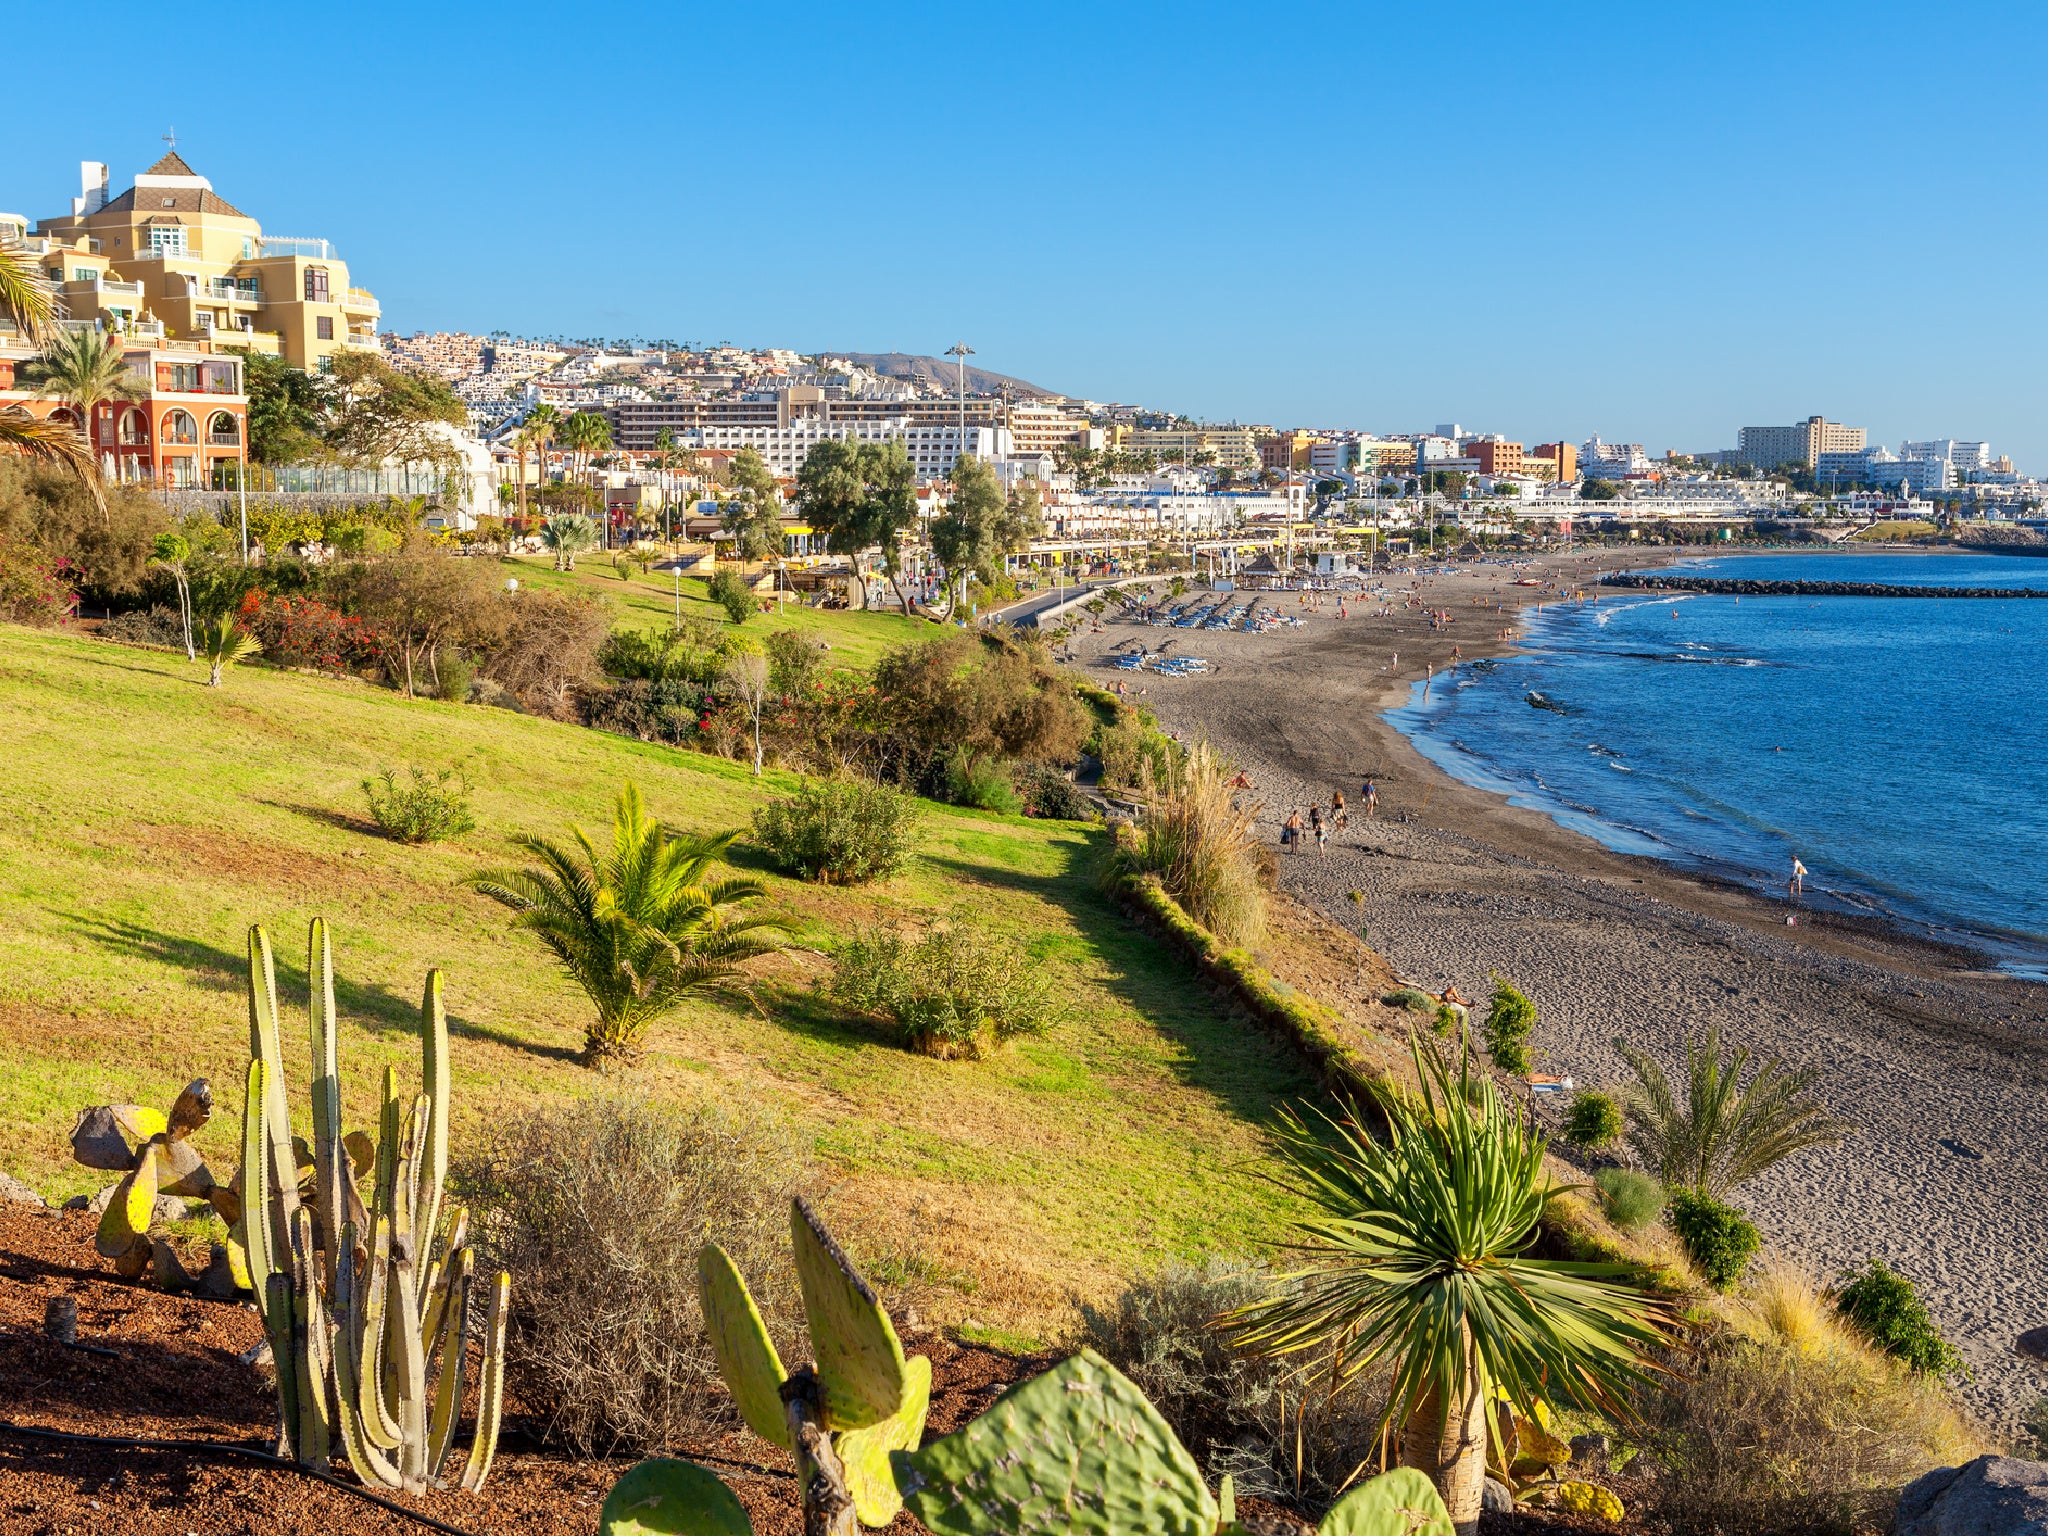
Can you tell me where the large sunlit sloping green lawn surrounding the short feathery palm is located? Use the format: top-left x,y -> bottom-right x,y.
0,626 -> 1313,1333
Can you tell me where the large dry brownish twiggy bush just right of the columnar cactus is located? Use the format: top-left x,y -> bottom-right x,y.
453,1098 -> 807,1456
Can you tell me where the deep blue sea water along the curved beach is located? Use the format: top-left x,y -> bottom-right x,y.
1389,553 -> 2048,973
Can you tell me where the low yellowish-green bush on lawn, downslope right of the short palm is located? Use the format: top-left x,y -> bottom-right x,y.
829,924 -> 1061,1059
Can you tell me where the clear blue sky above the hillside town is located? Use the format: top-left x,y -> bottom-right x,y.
12,0 -> 2048,471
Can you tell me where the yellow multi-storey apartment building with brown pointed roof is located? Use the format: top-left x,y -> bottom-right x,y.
27,150 -> 381,373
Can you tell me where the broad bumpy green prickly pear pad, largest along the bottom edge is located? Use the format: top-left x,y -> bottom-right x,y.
889,1350 -> 1212,1536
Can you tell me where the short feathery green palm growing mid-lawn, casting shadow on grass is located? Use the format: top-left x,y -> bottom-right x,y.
467,784 -> 786,1065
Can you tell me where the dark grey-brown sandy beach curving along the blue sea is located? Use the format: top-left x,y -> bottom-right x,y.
1073,551 -> 2048,1432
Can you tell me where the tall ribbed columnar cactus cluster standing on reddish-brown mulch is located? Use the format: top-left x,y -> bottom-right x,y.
233,918 -> 510,1493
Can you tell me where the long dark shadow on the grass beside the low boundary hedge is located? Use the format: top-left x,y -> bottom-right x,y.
924,840 -> 1321,1126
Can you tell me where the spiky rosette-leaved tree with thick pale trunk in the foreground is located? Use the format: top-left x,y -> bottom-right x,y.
1229,1040 -> 1669,1536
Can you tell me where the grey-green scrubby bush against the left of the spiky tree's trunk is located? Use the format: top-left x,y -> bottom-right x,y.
1081,1257 -> 1384,1509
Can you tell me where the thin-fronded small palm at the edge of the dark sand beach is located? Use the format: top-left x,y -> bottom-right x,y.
1614,1024 -> 1851,1200
